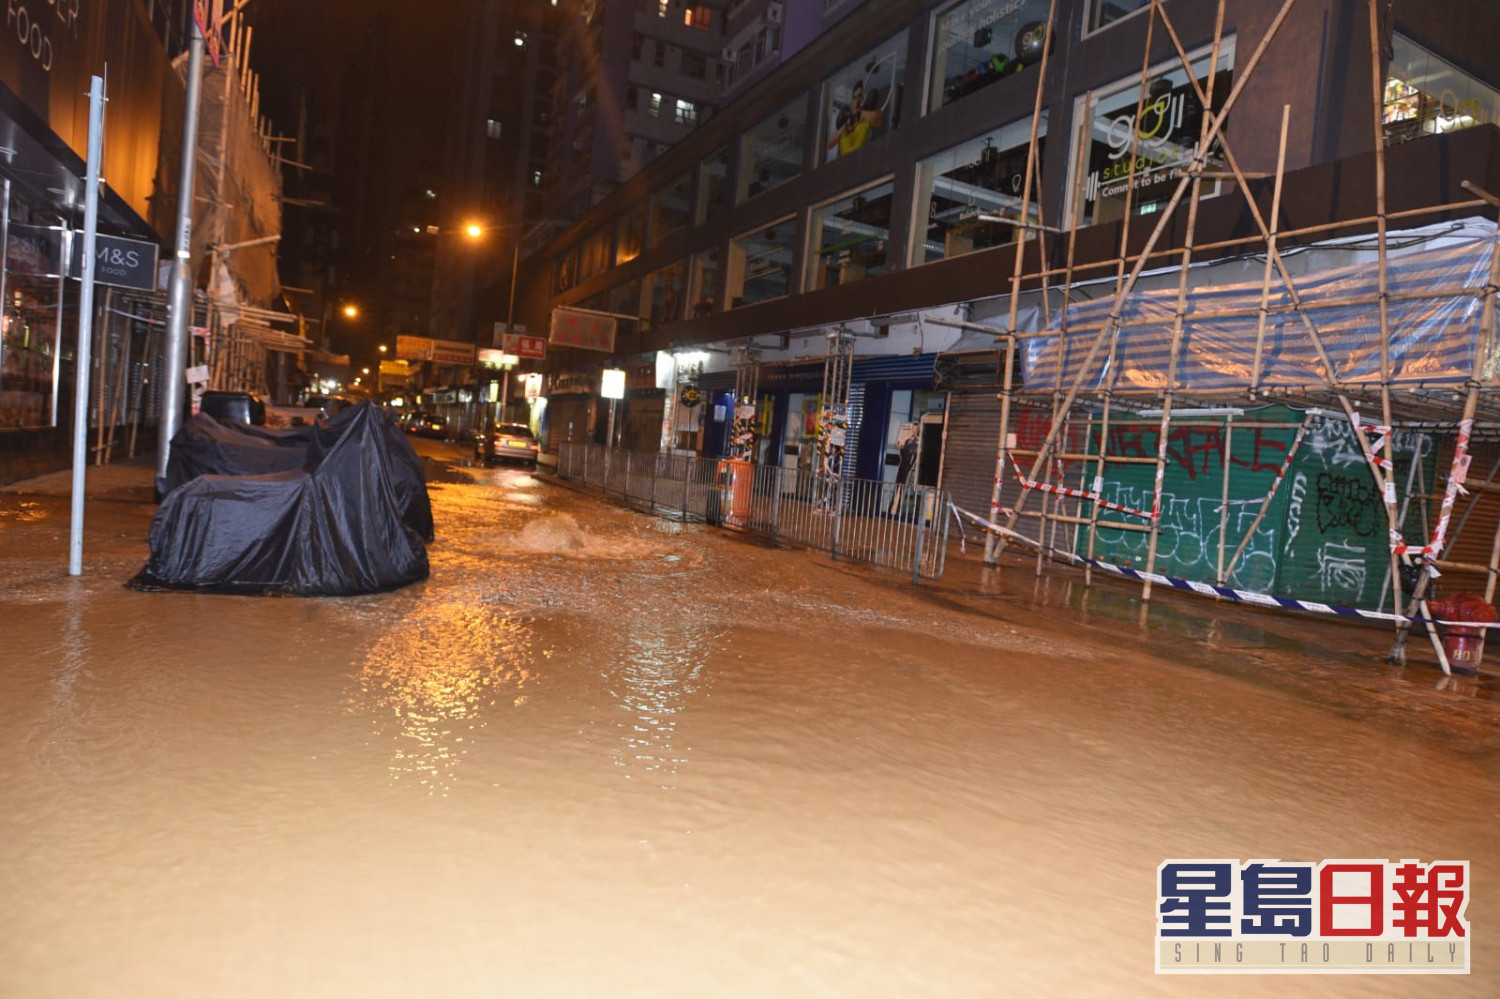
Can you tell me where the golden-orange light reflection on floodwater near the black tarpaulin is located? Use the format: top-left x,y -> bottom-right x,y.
353,602 -> 534,795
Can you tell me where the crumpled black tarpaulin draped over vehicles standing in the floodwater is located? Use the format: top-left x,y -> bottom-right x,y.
131,404 -> 432,597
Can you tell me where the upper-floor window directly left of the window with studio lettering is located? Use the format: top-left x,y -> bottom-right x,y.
912,116 -> 1047,264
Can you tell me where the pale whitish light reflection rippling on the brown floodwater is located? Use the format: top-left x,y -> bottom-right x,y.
603,620 -> 722,789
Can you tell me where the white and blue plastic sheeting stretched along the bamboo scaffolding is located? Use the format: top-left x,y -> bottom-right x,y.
1022,221 -> 1497,392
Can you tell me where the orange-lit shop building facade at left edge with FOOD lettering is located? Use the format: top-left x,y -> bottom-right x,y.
0,0 -> 189,482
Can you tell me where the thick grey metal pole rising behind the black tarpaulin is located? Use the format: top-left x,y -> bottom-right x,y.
156,18 -> 208,495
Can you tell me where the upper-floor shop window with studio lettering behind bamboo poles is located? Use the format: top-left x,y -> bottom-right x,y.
1073,38 -> 1235,225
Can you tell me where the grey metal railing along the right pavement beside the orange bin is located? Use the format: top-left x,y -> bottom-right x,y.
558,443 -> 950,582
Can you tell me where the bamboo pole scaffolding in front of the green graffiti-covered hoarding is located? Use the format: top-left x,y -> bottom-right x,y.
965,0 -> 1500,672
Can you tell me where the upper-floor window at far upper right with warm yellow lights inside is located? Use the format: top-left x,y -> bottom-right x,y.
1382,35 -> 1500,146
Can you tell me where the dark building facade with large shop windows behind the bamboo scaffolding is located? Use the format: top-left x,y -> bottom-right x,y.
513,0 -> 1500,615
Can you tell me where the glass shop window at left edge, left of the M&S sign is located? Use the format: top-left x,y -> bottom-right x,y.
0,222 -> 66,429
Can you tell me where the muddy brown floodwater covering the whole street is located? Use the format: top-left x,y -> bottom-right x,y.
0,444 -> 1500,999
